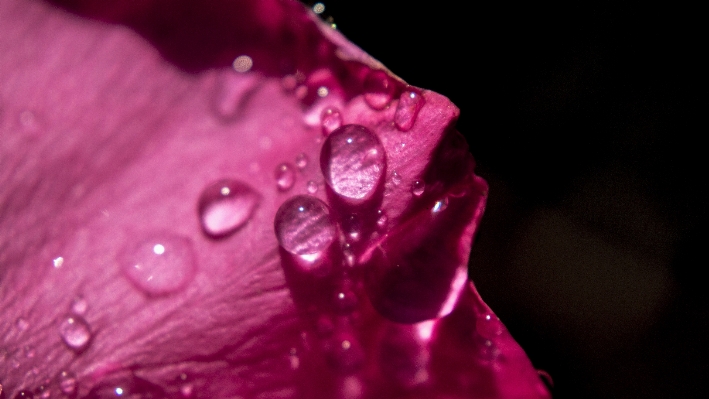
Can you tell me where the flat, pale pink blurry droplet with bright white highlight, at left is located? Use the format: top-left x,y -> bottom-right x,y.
122,233 -> 197,296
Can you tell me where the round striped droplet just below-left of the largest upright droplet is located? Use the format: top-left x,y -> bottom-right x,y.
275,195 -> 335,255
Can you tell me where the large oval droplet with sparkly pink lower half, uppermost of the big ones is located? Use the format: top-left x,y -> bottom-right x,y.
320,125 -> 386,202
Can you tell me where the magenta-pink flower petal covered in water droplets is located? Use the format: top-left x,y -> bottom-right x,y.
0,0 -> 549,399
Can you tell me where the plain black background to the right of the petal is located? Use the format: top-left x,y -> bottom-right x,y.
310,0 -> 709,398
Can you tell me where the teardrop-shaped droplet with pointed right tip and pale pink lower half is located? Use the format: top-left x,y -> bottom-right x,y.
199,180 -> 261,238
